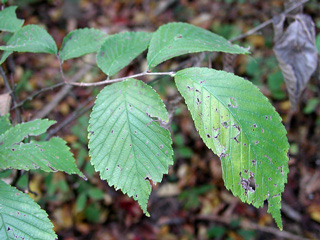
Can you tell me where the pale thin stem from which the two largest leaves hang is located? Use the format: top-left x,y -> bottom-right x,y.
67,72 -> 175,87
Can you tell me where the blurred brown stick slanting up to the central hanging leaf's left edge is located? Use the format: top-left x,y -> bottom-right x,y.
46,97 -> 94,140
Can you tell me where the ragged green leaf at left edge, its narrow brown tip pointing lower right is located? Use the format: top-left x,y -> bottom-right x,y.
0,137 -> 86,179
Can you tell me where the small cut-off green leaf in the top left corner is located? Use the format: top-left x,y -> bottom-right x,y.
0,6 -> 24,32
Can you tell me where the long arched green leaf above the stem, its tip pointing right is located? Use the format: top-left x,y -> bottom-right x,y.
147,23 -> 249,69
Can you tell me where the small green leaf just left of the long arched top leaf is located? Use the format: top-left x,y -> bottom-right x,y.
97,32 -> 152,76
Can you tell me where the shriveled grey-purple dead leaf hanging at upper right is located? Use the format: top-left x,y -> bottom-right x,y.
273,14 -> 318,110
